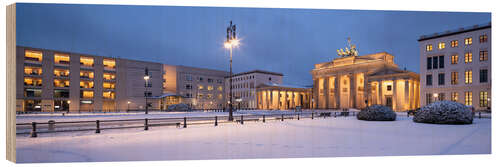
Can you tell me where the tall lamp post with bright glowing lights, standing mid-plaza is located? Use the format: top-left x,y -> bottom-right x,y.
224,21 -> 239,121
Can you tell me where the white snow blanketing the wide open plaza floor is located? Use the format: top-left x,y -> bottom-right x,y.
16,111 -> 491,162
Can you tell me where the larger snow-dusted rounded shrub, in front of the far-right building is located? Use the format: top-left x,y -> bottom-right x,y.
413,101 -> 474,124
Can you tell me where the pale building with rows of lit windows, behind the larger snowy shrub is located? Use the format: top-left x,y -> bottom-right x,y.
418,23 -> 491,110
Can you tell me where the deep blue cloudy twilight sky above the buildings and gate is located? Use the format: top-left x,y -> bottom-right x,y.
17,4 -> 491,85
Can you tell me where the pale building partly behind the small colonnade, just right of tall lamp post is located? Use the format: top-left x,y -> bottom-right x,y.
226,70 -> 283,109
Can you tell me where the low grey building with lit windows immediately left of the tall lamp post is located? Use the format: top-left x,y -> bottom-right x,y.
162,65 -> 229,109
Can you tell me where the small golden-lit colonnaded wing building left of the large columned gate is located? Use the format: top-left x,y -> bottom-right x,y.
256,83 -> 312,110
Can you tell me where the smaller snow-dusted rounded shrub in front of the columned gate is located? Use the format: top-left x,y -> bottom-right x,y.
357,105 -> 396,121
